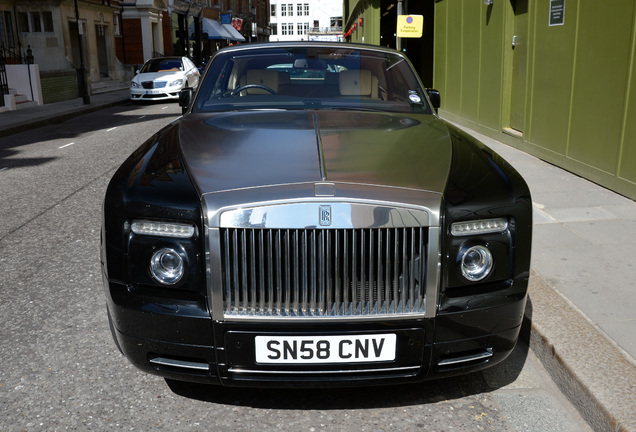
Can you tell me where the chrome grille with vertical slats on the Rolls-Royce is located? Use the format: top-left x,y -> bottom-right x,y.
220,227 -> 428,318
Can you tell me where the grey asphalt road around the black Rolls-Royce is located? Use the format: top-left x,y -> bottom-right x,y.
0,104 -> 589,432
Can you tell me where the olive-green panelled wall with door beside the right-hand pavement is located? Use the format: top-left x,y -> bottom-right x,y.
433,0 -> 636,199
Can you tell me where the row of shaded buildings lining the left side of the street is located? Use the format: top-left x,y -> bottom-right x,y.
0,0 -> 269,105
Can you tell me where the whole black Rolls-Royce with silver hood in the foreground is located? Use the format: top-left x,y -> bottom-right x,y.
101,42 -> 532,386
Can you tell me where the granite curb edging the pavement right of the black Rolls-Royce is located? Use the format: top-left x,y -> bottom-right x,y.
521,270 -> 636,432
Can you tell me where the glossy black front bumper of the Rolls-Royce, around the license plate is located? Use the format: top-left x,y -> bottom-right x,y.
107,282 -> 526,387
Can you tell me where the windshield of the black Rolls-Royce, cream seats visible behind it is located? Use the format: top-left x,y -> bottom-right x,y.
193,46 -> 432,113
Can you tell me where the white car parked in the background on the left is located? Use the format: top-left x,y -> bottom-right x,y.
130,57 -> 199,101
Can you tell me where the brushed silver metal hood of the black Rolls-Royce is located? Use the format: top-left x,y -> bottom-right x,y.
179,110 -> 451,194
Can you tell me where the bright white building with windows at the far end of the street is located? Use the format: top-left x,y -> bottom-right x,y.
269,0 -> 343,42
